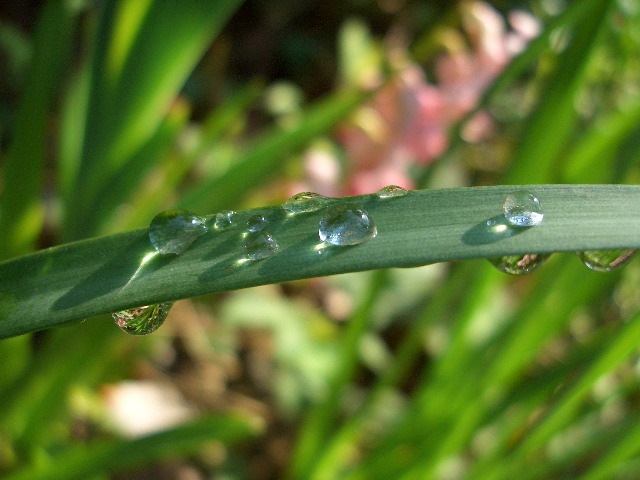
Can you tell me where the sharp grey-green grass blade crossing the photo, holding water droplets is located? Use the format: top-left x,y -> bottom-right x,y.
0,185 -> 640,337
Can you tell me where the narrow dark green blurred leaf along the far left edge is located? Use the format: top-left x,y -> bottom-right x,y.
0,0 -> 76,259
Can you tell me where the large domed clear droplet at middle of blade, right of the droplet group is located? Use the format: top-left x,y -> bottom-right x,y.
318,204 -> 378,246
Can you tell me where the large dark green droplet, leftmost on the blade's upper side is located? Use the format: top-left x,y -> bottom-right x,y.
149,210 -> 208,255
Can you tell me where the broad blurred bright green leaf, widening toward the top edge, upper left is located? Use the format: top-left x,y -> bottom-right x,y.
67,0 -> 241,238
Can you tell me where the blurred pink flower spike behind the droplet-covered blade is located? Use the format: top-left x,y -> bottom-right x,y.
332,1 -> 539,194
